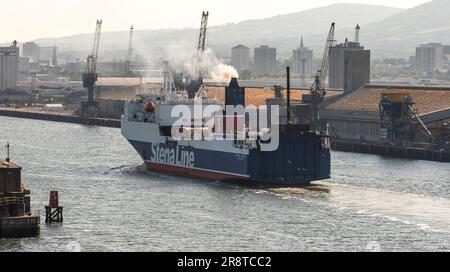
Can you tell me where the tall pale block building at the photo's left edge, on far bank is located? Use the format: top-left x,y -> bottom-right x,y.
0,42 -> 19,91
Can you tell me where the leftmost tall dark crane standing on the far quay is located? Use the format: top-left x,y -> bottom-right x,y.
83,20 -> 102,108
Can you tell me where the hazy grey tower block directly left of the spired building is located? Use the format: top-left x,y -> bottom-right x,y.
254,45 -> 277,76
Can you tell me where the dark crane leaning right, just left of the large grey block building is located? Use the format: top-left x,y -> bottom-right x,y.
303,23 -> 336,131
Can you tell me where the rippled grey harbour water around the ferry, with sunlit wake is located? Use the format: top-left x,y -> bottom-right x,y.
0,117 -> 450,251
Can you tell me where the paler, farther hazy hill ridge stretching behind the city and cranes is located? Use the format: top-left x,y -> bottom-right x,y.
36,4 -> 402,58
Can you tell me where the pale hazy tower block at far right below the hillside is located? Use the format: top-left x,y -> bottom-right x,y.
416,43 -> 444,73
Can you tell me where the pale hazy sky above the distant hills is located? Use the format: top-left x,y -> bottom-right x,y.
0,0 -> 430,42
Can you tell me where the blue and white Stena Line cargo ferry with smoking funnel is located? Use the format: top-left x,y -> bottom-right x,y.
121,74 -> 330,185
